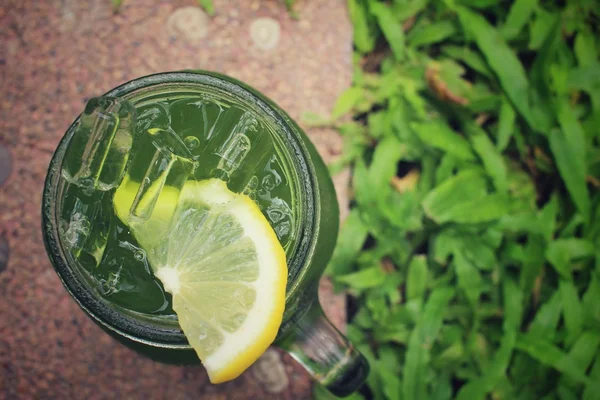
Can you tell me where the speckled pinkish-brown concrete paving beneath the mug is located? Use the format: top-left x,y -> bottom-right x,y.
0,0 -> 351,400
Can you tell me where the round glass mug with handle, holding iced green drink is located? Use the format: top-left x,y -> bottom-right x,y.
43,73 -> 368,394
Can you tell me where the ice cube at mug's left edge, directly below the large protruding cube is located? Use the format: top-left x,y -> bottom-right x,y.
61,185 -> 112,266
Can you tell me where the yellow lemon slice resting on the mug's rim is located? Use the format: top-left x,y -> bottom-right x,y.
114,179 -> 287,383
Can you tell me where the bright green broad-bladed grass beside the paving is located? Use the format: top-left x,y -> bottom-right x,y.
314,0 -> 600,400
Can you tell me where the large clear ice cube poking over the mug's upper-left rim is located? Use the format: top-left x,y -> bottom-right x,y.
63,97 -> 135,192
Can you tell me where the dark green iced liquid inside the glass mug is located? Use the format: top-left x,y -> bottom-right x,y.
61,93 -> 299,318
